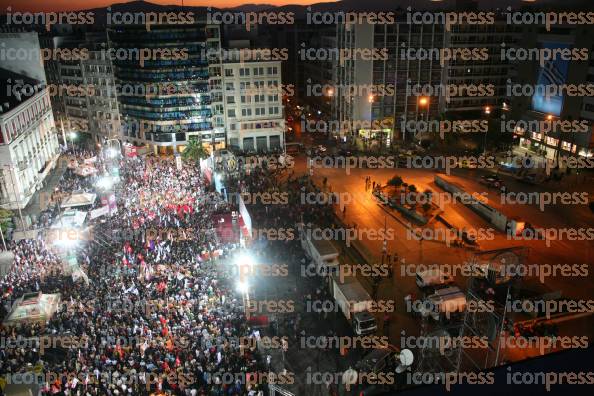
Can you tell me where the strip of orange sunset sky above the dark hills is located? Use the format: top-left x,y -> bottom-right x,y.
6,0 -> 334,14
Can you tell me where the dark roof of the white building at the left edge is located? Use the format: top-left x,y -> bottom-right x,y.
0,67 -> 45,115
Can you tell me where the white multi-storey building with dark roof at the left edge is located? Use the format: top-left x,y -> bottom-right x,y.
0,68 -> 60,210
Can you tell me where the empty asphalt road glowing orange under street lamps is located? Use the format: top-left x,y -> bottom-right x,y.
284,152 -> 594,366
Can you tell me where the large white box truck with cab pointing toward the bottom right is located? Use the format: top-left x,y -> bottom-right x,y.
331,276 -> 377,335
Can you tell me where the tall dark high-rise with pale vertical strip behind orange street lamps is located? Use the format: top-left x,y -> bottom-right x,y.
333,22 -> 446,144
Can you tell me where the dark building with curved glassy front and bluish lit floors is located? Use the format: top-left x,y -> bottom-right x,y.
108,22 -> 225,154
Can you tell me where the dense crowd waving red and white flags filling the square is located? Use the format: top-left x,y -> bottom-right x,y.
0,152 -> 266,395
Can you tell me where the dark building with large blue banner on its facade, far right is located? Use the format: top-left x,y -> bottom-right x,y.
506,25 -> 594,165
